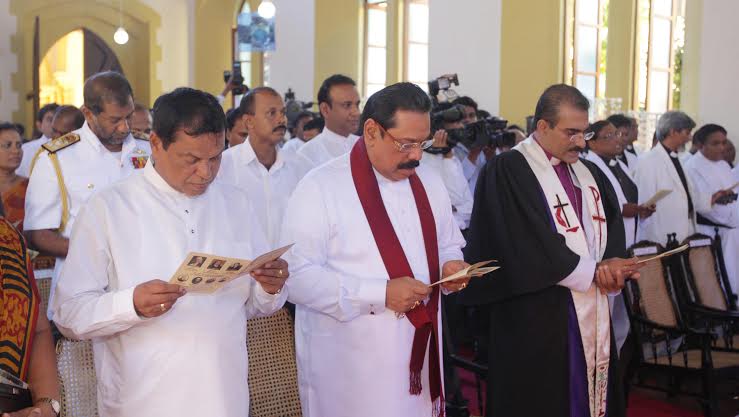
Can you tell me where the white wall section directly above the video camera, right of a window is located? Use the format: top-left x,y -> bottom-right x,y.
429,0 -> 501,115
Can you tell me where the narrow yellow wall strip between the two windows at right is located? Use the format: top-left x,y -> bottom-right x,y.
606,0 -> 637,105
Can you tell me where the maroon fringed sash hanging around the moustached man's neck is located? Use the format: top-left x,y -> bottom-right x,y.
350,138 -> 444,415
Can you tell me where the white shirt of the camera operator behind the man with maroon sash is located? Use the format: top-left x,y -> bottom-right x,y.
421,153 -> 473,230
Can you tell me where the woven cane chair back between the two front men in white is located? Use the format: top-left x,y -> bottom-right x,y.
247,308 -> 302,417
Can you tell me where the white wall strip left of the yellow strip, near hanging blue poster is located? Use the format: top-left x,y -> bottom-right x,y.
269,0 -> 316,101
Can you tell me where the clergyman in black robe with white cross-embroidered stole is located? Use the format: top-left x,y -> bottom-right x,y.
460,85 -> 638,417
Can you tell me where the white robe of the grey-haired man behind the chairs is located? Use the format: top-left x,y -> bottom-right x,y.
634,143 -> 711,245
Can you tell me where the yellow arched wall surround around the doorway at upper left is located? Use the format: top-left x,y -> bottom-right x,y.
10,0 -> 161,129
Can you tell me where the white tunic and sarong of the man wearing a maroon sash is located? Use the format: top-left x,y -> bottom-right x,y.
282,139 -> 464,417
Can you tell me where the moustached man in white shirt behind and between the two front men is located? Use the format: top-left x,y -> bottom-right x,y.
218,87 -> 305,247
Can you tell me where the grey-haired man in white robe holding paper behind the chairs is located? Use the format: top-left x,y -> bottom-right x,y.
634,111 -> 727,245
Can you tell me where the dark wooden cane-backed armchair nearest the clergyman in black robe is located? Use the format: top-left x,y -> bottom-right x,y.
624,242 -> 739,417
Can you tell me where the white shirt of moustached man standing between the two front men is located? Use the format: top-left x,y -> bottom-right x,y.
218,138 -> 306,248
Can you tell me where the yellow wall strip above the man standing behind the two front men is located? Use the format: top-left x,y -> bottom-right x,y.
313,0 -> 364,97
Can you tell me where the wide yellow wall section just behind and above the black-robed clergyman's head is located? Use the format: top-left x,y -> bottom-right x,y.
500,0 -> 564,125
